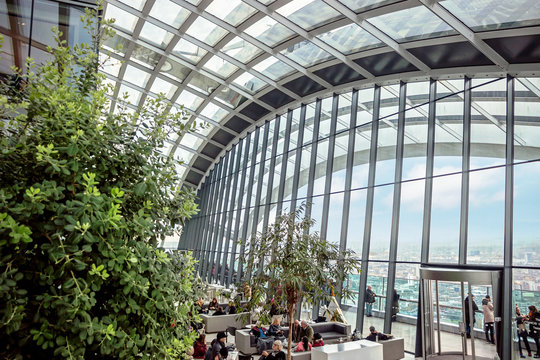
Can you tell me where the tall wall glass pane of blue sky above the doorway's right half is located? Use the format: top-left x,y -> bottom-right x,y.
467,167 -> 505,265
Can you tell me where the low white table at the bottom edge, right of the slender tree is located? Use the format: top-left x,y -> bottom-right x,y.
311,340 -> 383,360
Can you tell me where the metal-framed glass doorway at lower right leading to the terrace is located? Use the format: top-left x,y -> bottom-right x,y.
420,267 -> 503,360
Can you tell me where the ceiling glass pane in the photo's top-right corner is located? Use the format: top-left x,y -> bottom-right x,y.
441,0 -> 540,31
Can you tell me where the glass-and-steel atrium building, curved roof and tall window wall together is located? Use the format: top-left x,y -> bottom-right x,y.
0,0 -> 540,358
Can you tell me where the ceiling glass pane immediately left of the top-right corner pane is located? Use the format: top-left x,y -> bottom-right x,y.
368,6 -> 456,42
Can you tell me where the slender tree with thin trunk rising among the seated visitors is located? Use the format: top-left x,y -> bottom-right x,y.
239,205 -> 360,360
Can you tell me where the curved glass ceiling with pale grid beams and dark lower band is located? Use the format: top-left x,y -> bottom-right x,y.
101,0 -> 540,186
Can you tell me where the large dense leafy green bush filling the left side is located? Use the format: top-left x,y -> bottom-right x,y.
0,8 -> 202,359
